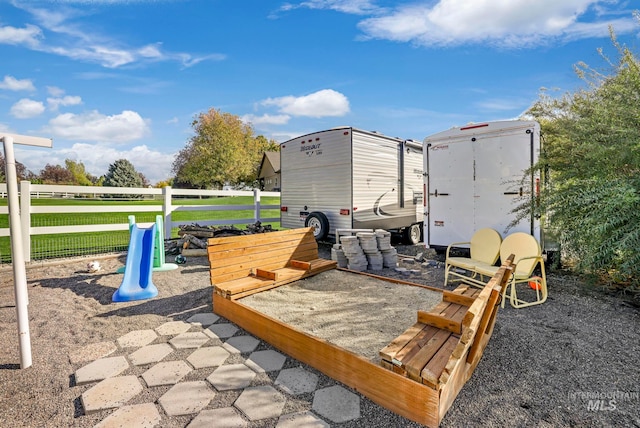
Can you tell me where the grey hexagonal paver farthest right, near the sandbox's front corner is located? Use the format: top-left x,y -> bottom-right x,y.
312,385 -> 360,423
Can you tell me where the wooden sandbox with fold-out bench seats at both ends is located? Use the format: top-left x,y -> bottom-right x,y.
207,229 -> 513,427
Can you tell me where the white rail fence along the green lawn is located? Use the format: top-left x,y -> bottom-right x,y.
0,181 -> 280,261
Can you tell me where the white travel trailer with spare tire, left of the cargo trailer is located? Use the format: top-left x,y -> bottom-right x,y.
280,127 -> 423,243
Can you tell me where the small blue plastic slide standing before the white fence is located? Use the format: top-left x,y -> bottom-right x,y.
111,224 -> 158,302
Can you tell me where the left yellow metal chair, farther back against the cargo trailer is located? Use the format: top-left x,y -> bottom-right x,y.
444,228 -> 508,286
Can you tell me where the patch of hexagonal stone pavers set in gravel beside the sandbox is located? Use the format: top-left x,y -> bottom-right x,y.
69,313 -> 368,428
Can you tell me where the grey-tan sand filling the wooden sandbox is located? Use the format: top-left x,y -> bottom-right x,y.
239,270 -> 442,362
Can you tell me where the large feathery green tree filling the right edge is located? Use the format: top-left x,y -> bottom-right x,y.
519,22 -> 640,285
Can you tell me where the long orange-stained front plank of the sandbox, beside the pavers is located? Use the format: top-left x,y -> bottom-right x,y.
213,294 -> 440,428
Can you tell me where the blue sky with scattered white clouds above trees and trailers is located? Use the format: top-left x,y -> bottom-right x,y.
0,0 -> 640,183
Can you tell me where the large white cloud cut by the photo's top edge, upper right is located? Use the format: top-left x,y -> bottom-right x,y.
358,0 -> 634,48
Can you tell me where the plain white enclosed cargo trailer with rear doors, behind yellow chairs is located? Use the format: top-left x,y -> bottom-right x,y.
424,120 -> 544,251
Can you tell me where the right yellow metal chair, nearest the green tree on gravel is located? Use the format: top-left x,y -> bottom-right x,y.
476,232 -> 547,308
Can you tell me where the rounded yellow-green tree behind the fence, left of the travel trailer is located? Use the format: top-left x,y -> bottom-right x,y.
172,109 -> 277,189
